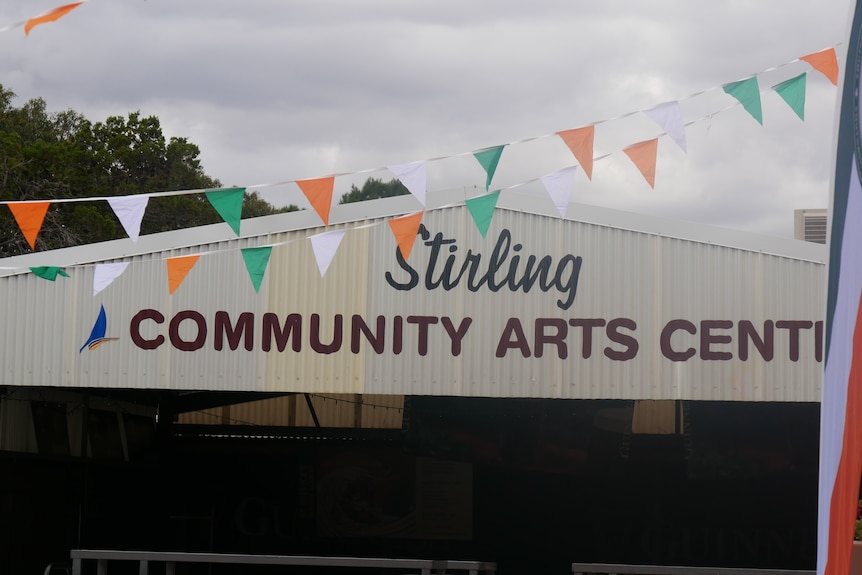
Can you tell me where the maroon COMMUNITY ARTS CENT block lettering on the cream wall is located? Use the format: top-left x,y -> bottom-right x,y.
129,309 -> 823,363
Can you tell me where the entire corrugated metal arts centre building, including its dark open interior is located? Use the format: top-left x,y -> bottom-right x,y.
0,190 -> 826,572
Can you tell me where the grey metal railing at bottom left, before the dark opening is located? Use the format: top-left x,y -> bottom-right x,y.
70,549 -> 497,575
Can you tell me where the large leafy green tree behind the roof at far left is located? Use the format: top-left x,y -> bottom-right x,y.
0,85 -> 298,257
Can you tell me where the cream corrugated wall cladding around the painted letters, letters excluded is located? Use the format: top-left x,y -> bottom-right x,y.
0,196 -> 824,402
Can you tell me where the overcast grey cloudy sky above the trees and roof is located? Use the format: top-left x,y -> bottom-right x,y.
0,0 -> 850,237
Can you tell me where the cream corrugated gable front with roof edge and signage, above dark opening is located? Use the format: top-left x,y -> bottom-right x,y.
0,189 -> 825,401
